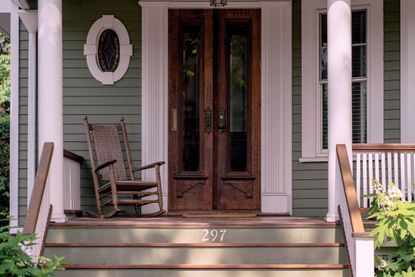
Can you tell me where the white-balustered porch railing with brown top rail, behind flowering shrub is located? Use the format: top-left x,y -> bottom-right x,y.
353,144 -> 415,208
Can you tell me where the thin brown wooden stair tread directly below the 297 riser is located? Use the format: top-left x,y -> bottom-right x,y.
45,242 -> 345,248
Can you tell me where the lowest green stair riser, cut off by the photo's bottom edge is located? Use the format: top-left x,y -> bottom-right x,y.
56,269 -> 351,277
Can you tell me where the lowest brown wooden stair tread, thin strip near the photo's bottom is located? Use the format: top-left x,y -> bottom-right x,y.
65,264 -> 350,269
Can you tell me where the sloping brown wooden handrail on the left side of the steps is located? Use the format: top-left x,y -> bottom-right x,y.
23,142 -> 53,234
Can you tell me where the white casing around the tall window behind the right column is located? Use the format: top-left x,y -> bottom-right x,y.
300,0 -> 384,162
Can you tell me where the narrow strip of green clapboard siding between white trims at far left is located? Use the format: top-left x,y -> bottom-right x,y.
18,23 -> 29,225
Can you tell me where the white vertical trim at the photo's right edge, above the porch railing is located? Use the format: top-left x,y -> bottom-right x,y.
401,0 -> 415,143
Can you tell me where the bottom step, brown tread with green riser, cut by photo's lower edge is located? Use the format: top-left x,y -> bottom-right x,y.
57,264 -> 351,277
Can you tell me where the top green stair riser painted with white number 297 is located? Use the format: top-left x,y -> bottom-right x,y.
47,227 -> 343,243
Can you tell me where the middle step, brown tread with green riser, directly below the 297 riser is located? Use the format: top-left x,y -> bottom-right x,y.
45,243 -> 348,265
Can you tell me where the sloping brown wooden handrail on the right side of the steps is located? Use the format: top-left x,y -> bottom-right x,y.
336,144 -> 365,233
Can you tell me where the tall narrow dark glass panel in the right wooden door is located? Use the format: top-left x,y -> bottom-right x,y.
228,24 -> 249,172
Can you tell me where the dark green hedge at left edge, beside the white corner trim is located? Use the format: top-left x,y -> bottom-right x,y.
0,115 -> 10,223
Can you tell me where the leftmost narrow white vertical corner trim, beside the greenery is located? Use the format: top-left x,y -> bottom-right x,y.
10,8 -> 20,230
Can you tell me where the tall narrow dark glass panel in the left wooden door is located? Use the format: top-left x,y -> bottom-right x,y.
181,26 -> 201,171
